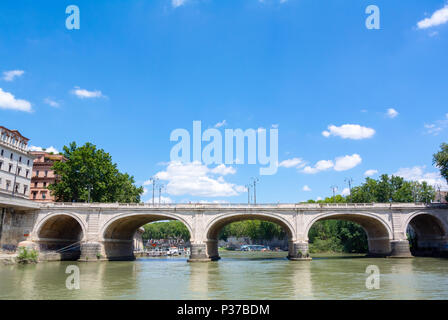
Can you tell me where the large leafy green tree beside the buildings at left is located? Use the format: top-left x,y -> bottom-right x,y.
49,142 -> 143,203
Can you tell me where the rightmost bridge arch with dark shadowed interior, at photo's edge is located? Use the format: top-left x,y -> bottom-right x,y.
404,211 -> 448,255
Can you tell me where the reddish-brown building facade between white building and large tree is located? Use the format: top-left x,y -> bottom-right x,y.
29,151 -> 66,202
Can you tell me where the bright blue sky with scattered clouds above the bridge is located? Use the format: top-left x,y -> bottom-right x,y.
0,0 -> 448,202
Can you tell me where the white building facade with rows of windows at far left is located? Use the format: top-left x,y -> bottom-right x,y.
0,126 -> 33,199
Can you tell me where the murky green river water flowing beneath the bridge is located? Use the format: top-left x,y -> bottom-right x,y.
0,252 -> 448,300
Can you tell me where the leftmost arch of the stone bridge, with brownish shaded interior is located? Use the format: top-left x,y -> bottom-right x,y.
32,212 -> 87,255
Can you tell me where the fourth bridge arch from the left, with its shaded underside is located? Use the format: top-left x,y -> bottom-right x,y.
304,212 -> 394,256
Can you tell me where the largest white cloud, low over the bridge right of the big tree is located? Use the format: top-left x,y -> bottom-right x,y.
145,162 -> 245,197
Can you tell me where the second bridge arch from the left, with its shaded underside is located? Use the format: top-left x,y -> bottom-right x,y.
99,212 -> 193,260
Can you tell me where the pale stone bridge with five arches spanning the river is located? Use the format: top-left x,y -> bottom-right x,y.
15,203 -> 448,261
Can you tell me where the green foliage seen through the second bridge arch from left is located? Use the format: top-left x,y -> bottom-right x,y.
142,221 -> 190,241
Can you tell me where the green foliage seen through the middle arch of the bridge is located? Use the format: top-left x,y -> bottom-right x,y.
219,220 -> 286,240
